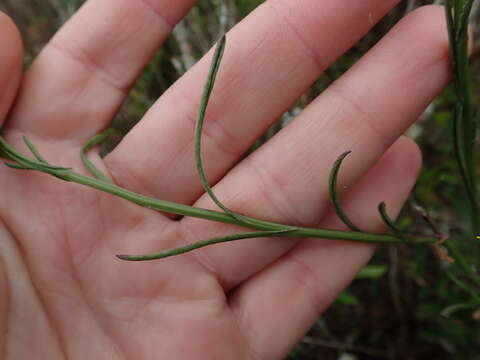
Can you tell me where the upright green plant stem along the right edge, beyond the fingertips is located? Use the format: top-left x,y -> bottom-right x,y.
443,0 -> 480,315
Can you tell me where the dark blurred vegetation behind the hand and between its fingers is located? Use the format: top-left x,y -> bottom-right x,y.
0,0 -> 480,360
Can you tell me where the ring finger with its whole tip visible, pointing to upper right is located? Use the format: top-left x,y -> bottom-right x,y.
182,7 -> 450,289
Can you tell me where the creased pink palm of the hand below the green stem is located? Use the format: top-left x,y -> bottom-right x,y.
2,148 -> 253,359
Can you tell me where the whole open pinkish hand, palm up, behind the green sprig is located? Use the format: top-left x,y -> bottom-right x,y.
0,0 -> 449,360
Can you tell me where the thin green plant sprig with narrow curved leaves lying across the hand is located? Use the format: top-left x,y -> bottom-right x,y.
0,37 -> 437,261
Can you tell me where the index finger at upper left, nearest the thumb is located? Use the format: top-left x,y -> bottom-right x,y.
5,0 -> 195,142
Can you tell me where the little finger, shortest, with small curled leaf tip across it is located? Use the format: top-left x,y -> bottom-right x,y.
230,138 -> 420,359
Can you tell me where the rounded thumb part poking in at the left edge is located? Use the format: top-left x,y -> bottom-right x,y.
0,12 -> 23,126
